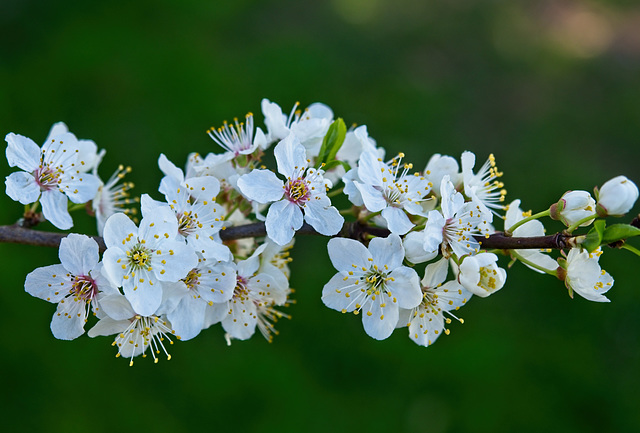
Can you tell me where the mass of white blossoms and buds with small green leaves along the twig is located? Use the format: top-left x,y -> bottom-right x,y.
6,99 -> 640,364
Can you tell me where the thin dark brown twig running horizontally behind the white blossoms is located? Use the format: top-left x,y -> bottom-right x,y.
0,221 -> 575,251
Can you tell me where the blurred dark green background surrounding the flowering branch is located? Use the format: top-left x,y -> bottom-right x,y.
0,0 -> 640,432
